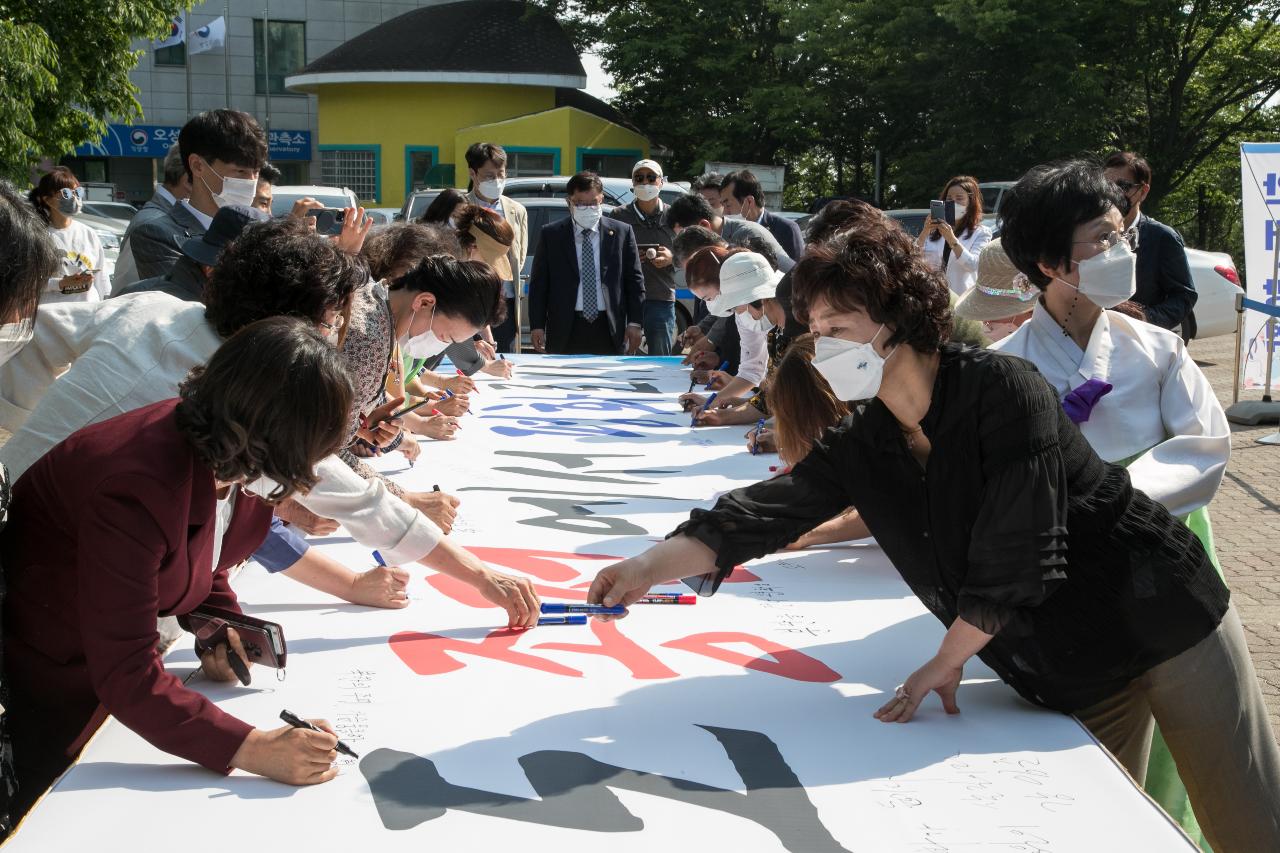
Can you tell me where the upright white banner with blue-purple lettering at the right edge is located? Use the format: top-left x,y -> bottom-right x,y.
1239,142 -> 1280,388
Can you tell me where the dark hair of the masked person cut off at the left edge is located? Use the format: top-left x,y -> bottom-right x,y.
0,181 -> 59,328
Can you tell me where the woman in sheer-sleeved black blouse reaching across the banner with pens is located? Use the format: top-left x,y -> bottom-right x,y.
589,208 -> 1280,853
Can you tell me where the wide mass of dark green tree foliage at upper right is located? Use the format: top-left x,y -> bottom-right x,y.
538,0 -> 1280,249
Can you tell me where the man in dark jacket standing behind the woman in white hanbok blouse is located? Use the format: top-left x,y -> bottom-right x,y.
1105,151 -> 1197,333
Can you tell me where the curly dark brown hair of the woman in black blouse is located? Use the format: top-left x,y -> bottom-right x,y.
791,216 -> 951,352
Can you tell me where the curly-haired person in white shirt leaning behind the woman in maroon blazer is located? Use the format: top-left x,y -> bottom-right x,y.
0,220 -> 538,626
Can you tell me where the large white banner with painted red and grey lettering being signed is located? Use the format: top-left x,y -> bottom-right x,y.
10,356 -> 1193,853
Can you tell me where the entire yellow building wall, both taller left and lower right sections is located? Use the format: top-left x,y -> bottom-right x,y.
315,83 -> 649,207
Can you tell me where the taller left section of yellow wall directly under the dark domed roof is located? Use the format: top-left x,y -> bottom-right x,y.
316,83 -> 556,207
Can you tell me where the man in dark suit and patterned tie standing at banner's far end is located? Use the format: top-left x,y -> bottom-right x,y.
529,172 -> 644,355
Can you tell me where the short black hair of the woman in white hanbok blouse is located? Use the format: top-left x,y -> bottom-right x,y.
1000,158 -> 1125,289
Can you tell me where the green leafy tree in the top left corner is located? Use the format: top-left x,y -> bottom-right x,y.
0,0 -> 187,181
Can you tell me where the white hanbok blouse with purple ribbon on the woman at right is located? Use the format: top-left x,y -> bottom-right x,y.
991,302 -> 1231,516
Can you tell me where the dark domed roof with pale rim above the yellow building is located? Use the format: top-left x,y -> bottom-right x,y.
288,0 -> 586,88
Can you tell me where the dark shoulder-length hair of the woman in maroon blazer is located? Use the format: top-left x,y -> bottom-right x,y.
175,316 -> 353,502
